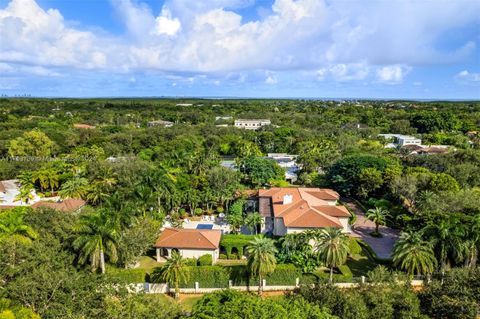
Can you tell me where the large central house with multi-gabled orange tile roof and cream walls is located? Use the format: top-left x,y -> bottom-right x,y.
258,188 -> 351,236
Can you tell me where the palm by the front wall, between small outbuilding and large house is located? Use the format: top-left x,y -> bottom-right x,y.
247,237 -> 277,295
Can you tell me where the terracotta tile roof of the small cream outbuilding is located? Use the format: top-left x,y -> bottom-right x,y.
154,228 -> 222,250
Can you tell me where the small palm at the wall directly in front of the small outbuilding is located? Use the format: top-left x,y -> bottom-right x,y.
152,250 -> 190,299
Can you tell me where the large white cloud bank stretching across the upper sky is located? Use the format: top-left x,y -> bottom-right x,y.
0,0 -> 480,84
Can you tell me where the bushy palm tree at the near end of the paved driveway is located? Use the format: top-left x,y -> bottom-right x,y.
393,232 -> 437,275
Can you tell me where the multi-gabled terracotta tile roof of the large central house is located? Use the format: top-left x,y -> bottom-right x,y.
258,188 -> 350,228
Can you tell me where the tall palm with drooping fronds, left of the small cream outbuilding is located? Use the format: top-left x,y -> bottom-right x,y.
73,212 -> 118,274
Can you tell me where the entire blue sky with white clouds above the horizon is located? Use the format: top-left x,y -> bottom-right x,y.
0,0 -> 480,99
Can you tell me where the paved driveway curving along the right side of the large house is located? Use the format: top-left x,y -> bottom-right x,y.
344,200 -> 399,258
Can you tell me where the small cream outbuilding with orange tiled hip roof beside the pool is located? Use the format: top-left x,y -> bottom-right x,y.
154,228 -> 222,263
